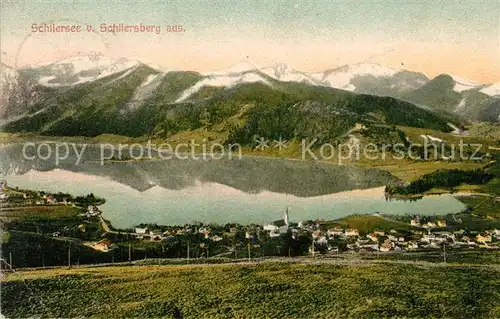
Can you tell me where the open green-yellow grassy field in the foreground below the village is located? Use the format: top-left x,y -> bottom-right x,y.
1,262 -> 500,318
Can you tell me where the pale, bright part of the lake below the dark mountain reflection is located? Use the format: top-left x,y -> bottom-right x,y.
7,169 -> 464,228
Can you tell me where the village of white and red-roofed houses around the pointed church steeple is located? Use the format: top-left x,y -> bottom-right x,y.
113,211 -> 500,254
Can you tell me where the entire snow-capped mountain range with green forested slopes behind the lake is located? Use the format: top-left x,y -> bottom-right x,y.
0,54 -> 500,140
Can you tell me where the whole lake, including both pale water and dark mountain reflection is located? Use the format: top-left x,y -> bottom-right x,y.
0,146 -> 465,228
